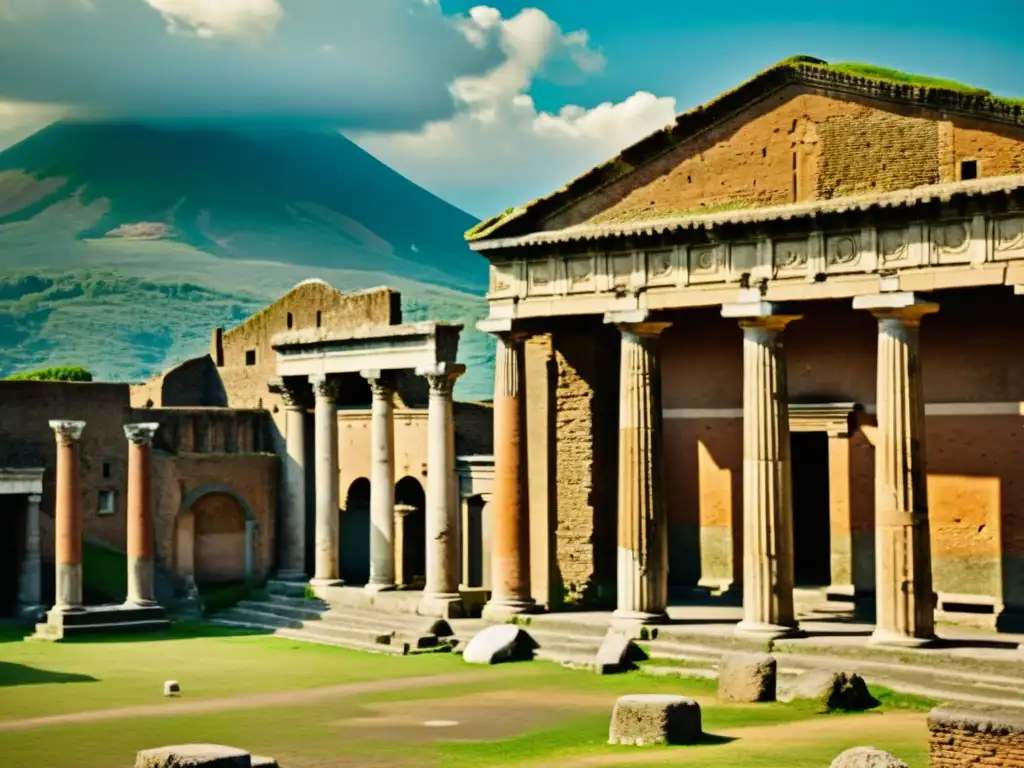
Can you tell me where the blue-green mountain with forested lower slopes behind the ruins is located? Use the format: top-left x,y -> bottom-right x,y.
0,122 -> 493,398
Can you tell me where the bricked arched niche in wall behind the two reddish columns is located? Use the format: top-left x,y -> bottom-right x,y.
174,484 -> 256,584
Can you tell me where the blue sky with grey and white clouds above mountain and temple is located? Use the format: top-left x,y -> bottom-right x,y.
0,0 -> 1024,218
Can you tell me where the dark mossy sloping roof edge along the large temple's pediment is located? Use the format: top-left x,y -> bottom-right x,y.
465,55 -> 1024,242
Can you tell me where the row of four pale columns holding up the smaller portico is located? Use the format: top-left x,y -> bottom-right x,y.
278,362 -> 466,615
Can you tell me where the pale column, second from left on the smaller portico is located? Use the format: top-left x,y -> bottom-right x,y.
309,376 -> 342,586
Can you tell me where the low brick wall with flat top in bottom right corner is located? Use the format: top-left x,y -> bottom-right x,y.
928,706 -> 1024,768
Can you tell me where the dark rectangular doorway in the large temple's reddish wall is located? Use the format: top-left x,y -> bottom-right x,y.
790,432 -> 831,587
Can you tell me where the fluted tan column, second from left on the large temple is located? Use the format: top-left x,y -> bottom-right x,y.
606,313 -> 671,624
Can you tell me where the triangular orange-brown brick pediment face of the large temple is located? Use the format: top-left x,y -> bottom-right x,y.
543,85 -> 1024,229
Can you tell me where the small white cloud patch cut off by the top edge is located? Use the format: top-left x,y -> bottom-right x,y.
144,0 -> 285,40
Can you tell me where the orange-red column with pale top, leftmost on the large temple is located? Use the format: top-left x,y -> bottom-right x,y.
483,333 -> 536,618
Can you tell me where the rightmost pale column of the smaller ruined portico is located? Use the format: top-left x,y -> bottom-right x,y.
417,362 -> 466,617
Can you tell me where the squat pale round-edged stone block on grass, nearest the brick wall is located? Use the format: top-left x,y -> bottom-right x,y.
608,693 -> 703,746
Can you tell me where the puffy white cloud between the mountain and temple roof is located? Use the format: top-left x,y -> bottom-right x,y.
348,7 -> 677,215
